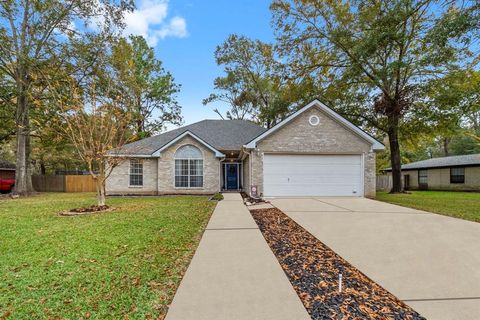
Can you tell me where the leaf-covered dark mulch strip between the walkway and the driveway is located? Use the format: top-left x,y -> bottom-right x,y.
251,208 -> 425,320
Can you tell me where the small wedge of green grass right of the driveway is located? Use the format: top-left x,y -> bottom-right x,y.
376,191 -> 480,222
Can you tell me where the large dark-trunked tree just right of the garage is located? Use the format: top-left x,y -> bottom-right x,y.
271,0 -> 457,192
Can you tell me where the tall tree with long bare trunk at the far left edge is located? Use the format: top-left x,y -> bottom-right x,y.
0,0 -> 133,194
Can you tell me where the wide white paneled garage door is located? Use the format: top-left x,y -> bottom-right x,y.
263,154 -> 363,197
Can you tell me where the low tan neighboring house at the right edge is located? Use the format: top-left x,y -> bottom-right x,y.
385,154 -> 480,191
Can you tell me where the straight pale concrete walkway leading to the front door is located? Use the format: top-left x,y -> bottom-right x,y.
166,193 -> 310,320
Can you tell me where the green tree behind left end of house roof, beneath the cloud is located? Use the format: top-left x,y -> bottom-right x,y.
111,36 -> 182,138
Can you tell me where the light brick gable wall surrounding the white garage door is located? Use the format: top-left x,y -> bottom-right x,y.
247,107 -> 376,198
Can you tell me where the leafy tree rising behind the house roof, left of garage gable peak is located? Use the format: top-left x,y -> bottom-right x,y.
203,34 -> 312,128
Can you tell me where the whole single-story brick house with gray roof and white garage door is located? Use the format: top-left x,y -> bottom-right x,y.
106,100 -> 384,197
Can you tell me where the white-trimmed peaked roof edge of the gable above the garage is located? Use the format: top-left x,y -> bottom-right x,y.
244,100 -> 385,150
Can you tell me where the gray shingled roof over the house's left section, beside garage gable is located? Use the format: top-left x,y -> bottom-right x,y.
116,120 -> 267,155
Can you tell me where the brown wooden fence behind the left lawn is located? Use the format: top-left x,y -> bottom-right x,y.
32,175 -> 96,192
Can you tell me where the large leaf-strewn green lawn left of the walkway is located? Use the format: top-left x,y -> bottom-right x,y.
0,193 -> 215,319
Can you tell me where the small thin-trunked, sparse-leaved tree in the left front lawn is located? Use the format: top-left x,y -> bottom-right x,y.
58,76 -> 134,206
